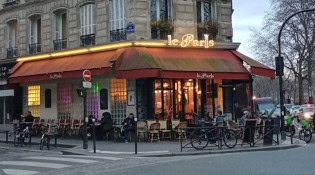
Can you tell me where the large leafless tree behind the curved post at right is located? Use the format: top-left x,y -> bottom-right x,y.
251,0 -> 315,104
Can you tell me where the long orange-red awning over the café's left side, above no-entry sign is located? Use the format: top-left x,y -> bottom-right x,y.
9,50 -> 117,83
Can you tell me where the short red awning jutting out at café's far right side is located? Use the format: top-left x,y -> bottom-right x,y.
231,50 -> 275,79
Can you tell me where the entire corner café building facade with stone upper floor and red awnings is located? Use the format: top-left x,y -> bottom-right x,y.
0,0 -> 274,126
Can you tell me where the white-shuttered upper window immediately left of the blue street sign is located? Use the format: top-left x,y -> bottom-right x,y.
110,0 -> 126,30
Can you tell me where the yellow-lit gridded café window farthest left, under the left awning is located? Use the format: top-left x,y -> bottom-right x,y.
27,85 -> 40,117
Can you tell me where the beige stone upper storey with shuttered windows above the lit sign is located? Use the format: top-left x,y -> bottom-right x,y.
0,0 -> 233,62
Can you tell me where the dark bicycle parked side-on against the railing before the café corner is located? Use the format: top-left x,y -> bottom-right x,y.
190,127 -> 237,150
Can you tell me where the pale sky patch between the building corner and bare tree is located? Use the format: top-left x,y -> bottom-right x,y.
232,0 -> 270,57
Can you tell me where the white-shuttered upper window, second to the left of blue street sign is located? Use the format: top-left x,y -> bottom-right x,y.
80,4 -> 95,35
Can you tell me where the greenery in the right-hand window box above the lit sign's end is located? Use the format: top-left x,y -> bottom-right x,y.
197,20 -> 218,40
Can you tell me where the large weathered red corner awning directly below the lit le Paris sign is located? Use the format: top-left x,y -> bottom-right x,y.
116,47 -> 249,79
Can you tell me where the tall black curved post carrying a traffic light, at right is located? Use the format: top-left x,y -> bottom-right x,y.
276,9 -> 315,140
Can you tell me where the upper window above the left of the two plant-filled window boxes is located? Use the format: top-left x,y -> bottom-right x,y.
151,0 -> 172,21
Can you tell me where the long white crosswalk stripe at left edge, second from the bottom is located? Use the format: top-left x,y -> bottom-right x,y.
0,161 -> 71,169
